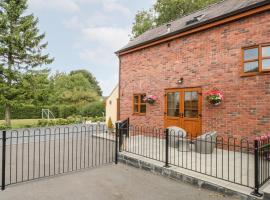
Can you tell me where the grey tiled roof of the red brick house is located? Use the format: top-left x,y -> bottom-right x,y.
116,0 -> 270,53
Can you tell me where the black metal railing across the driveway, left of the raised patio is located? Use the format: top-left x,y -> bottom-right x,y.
0,124 -> 117,190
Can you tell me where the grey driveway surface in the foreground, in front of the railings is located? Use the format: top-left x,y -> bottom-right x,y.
0,164 -> 238,200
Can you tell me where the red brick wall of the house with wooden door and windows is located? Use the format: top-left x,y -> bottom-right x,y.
120,11 -> 270,137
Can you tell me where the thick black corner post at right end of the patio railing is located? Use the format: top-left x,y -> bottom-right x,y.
251,140 -> 263,197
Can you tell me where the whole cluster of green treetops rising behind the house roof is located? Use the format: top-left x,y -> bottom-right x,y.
132,0 -> 221,37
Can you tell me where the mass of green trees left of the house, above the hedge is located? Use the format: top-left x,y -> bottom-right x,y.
0,0 -> 104,125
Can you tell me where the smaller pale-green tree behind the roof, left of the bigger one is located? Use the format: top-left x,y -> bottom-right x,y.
132,10 -> 154,38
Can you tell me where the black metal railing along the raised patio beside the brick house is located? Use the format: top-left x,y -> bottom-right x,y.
119,126 -> 270,195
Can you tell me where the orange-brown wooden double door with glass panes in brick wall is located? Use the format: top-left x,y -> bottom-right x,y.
164,88 -> 202,137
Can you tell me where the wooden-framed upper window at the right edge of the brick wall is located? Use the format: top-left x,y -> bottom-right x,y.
243,45 -> 270,75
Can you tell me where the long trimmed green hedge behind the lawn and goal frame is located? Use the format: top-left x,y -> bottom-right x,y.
0,102 -> 104,120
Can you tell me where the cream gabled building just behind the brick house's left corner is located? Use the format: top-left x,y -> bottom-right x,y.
106,84 -> 119,124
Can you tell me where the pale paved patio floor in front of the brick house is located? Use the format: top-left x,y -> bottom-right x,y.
115,135 -> 254,187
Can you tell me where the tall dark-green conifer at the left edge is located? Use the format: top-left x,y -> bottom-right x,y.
0,0 -> 53,125
